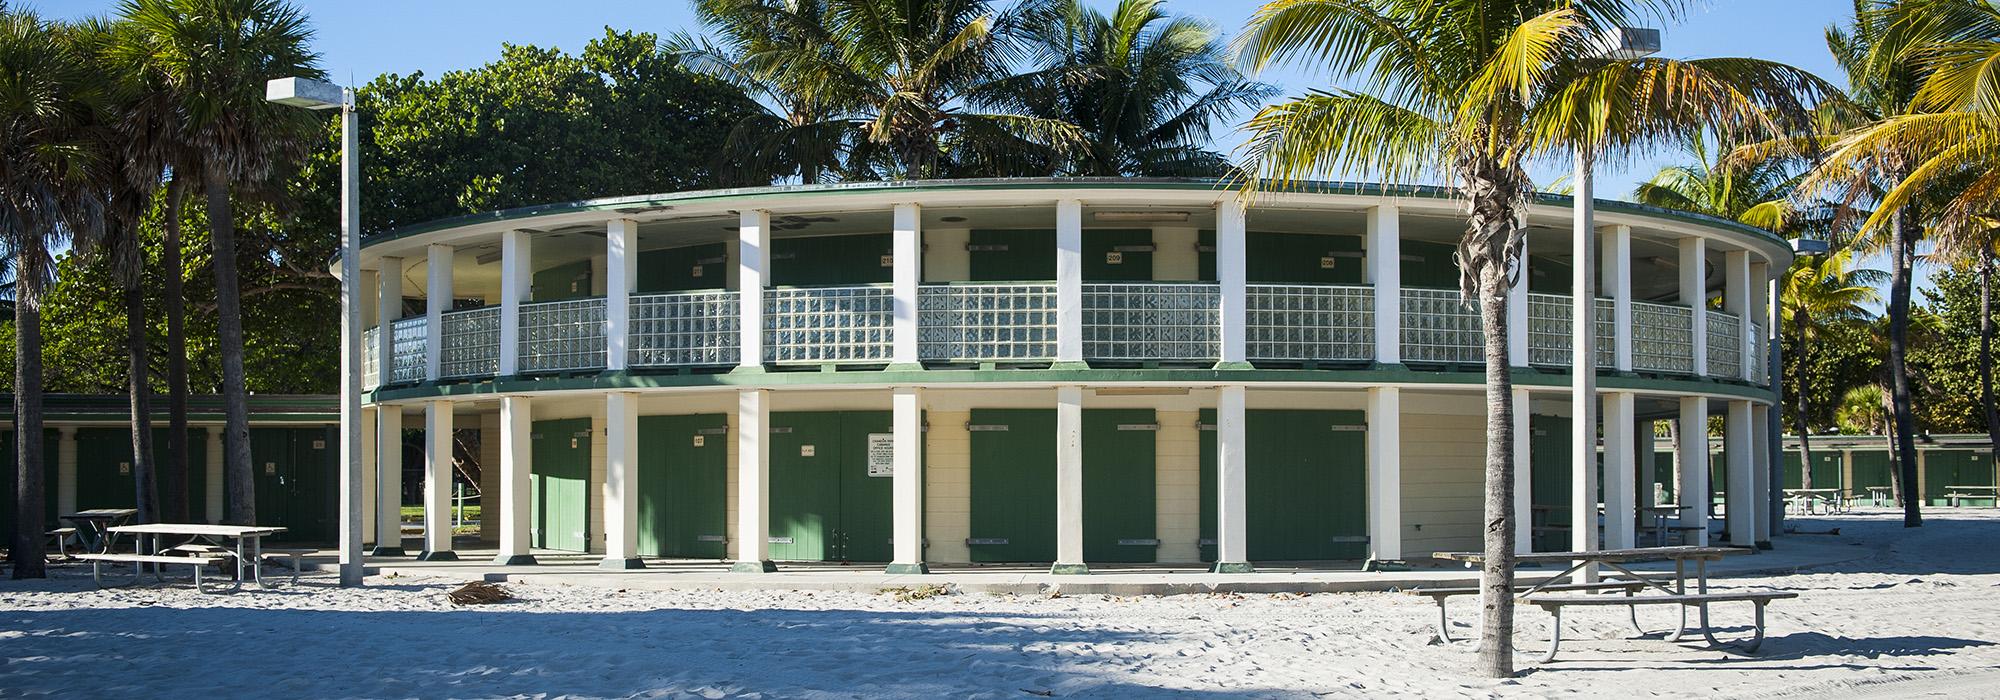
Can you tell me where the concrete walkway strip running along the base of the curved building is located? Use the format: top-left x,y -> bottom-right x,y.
310,536 -> 1870,596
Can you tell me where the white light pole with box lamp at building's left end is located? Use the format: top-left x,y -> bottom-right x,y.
264,78 -> 362,586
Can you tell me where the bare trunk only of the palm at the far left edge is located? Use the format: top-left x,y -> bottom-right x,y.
10,249 -> 48,578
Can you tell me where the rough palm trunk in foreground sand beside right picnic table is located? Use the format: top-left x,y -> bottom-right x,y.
1474,253 -> 1526,678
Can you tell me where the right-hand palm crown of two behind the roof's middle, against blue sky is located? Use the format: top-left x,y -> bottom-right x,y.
980,0 -> 1276,176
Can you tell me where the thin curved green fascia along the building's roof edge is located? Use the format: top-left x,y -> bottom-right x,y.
362,178 -> 1790,248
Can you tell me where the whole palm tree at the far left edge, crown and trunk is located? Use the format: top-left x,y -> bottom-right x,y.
0,10 -> 104,578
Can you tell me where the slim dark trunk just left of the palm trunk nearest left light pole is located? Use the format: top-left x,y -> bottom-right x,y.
160,174 -> 188,522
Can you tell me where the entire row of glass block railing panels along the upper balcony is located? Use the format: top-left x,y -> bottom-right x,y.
362,282 -> 1766,388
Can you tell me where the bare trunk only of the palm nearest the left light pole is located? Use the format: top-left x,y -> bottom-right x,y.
204,172 -> 256,524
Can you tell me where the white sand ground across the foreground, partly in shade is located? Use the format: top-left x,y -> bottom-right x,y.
0,510 -> 2000,698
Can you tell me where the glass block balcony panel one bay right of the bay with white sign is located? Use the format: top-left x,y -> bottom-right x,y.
916,284 -> 1056,362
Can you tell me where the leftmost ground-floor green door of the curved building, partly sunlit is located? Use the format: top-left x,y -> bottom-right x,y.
528,418 -> 590,552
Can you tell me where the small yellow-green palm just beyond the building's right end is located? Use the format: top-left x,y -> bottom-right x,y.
1778,248 -> 1886,488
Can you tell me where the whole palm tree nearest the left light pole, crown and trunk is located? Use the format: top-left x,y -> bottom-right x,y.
120,0 -> 322,524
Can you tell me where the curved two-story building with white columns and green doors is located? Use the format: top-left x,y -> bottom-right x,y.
362,180 -> 1790,574
